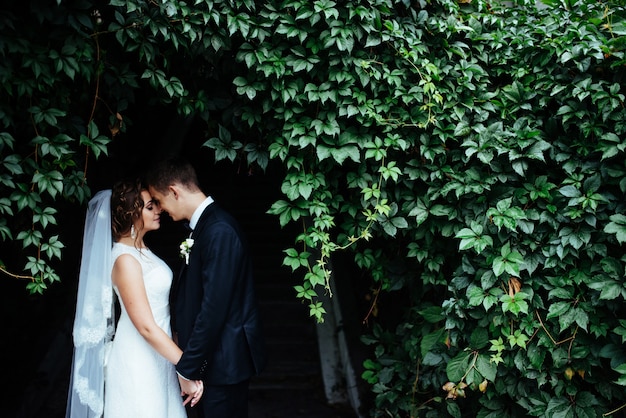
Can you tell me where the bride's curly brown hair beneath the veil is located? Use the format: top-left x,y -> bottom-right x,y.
111,180 -> 145,241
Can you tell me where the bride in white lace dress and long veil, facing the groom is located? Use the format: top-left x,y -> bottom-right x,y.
66,182 -> 204,418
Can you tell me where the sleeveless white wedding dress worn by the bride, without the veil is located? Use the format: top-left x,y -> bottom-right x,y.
104,243 -> 186,418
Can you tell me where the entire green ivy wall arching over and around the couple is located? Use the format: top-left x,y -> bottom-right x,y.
0,0 -> 626,417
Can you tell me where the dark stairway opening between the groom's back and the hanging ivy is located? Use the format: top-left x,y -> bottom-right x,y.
221,171 -> 355,418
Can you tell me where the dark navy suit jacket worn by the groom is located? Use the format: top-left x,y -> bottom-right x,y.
171,203 -> 266,385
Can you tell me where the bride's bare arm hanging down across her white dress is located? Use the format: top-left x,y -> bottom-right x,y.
111,254 -> 183,364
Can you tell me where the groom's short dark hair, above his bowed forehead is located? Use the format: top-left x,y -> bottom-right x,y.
145,157 -> 200,193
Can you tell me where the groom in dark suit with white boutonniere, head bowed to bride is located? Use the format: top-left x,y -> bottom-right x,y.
146,159 -> 265,418
